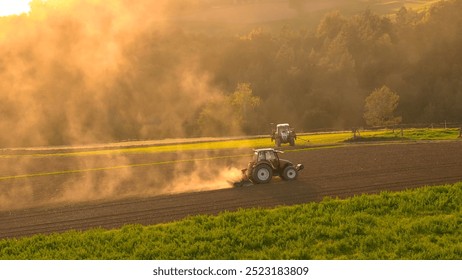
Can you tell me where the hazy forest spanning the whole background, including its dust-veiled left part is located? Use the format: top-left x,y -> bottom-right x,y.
0,0 -> 462,148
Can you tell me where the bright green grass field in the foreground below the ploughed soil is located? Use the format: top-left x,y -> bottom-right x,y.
0,183 -> 462,260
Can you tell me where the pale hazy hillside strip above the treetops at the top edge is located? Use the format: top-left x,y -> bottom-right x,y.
169,0 -> 438,32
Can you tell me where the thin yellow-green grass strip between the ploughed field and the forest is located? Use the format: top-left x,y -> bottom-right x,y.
0,128 -> 460,159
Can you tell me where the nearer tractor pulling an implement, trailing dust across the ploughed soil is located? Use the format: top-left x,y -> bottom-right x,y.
234,148 -> 303,187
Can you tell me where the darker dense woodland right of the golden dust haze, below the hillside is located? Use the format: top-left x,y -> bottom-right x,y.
184,1 -> 462,136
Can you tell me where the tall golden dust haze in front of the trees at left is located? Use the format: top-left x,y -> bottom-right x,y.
0,0 -> 235,147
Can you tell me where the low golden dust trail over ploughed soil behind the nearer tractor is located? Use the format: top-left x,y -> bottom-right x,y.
0,147 -> 253,211
